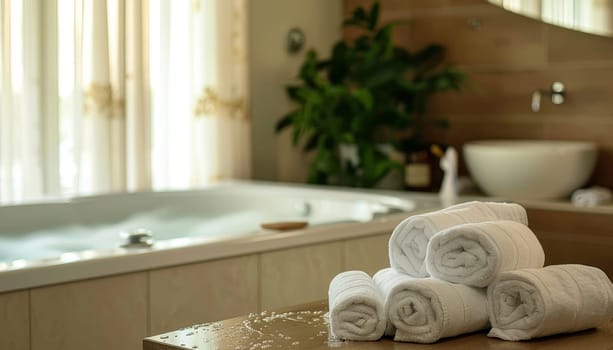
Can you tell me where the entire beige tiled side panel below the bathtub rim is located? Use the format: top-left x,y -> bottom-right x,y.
0,230 -> 392,350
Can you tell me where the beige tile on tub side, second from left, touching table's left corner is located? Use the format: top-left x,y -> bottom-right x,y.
30,273 -> 148,350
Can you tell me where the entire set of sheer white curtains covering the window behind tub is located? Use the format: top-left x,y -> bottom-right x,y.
0,0 -> 250,201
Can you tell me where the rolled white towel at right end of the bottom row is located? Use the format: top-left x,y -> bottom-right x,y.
487,265 -> 613,340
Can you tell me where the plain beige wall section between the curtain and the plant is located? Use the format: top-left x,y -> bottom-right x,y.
248,0 -> 343,182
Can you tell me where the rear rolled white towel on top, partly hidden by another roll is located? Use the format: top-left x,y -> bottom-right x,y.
389,202 -> 528,277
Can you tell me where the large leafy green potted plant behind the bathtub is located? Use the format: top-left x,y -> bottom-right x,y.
276,2 -> 465,187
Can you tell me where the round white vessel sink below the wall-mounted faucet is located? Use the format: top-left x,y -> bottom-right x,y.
463,140 -> 597,199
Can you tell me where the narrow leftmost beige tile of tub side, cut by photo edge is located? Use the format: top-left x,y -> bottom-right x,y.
0,290 -> 30,350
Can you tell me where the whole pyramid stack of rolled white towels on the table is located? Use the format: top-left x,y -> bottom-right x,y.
328,202 -> 613,343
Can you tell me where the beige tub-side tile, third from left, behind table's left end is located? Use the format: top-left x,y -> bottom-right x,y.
149,255 -> 259,334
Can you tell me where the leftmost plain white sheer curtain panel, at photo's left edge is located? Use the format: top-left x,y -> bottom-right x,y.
0,0 -> 44,201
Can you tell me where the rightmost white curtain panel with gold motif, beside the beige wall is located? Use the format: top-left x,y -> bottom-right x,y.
150,0 -> 250,188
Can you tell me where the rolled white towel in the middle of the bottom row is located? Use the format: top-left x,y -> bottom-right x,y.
374,268 -> 489,343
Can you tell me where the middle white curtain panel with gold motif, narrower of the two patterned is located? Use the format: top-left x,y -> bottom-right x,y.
77,0 -> 151,193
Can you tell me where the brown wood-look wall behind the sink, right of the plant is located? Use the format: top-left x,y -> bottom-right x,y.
344,0 -> 613,187
